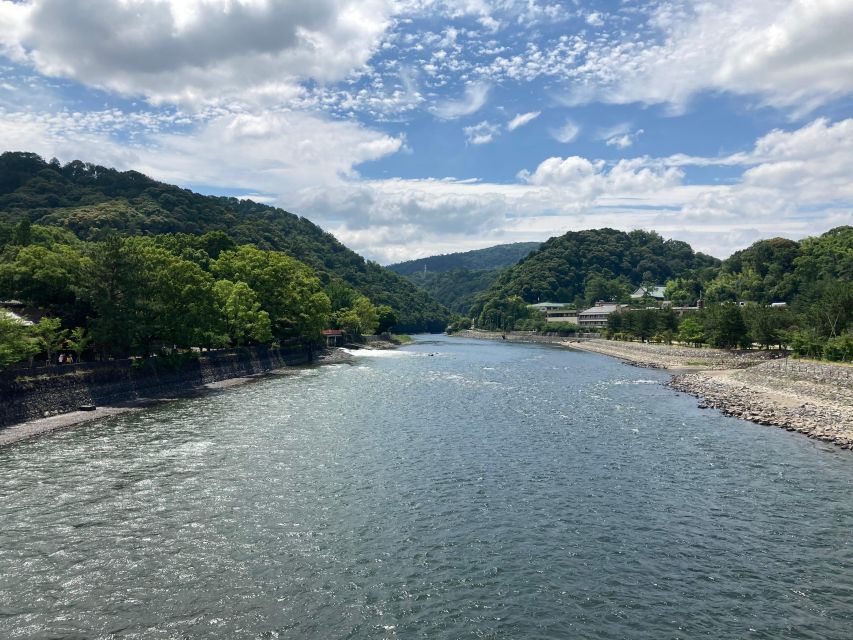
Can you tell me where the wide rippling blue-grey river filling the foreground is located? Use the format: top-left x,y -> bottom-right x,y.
0,337 -> 853,640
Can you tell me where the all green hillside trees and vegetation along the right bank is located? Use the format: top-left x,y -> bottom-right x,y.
470,227 -> 853,361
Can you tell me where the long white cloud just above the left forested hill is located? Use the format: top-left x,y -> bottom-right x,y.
0,110 -> 403,190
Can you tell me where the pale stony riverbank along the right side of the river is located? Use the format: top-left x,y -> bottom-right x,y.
452,331 -> 853,450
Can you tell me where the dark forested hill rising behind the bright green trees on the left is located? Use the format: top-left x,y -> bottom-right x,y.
0,153 -> 449,331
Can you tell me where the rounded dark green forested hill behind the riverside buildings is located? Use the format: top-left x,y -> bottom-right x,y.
474,229 -> 720,315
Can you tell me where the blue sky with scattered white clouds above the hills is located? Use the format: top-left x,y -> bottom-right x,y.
0,0 -> 853,264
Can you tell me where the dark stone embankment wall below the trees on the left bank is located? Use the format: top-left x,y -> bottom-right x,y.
0,346 -> 313,428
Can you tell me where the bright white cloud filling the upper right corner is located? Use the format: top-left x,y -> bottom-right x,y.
567,0 -> 853,112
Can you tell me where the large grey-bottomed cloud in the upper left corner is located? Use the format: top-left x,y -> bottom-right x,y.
0,0 -> 393,104
